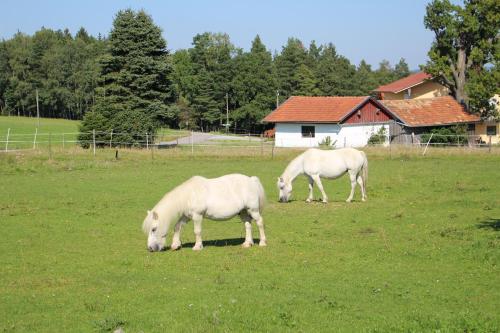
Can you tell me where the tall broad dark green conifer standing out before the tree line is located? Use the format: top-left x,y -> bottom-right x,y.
82,10 -> 176,143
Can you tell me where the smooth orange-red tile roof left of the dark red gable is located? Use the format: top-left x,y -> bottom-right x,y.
263,96 -> 370,123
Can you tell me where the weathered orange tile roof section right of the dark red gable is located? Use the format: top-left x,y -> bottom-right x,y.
380,96 -> 480,127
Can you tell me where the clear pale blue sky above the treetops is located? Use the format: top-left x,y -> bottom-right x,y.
0,0 -> 433,69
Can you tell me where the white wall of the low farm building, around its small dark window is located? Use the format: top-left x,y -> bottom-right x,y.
275,123 -> 389,148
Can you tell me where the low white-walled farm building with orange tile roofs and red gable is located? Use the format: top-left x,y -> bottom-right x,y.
263,96 -> 480,147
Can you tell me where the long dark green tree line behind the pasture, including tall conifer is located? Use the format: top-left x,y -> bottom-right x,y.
0,10 -> 410,131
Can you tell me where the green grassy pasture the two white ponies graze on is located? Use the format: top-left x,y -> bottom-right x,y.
0,150 -> 500,332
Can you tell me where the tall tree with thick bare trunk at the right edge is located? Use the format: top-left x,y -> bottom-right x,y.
424,0 -> 500,112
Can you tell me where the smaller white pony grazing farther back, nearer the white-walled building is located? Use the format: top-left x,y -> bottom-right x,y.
278,148 -> 368,203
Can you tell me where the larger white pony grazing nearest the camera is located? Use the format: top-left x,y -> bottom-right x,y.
142,174 -> 266,251
